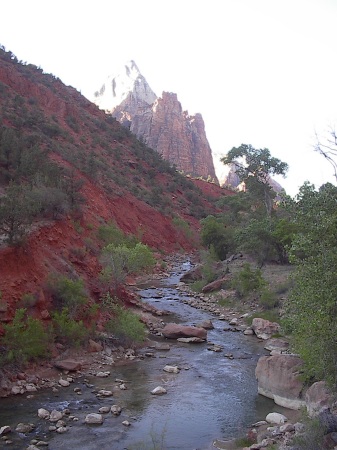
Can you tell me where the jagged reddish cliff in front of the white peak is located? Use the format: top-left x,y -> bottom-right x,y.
113,92 -> 217,181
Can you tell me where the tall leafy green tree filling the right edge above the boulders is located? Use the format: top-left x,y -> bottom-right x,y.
286,183 -> 337,386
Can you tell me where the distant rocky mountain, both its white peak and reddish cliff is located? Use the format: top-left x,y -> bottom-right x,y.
93,61 -> 217,182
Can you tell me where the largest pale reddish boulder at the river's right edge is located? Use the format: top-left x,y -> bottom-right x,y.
255,355 -> 305,409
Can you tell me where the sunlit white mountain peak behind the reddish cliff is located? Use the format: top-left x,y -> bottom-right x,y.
94,59 -> 157,112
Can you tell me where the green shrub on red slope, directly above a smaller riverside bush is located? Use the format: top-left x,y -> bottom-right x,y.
48,275 -> 88,318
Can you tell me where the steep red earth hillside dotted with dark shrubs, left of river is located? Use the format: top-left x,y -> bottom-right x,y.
0,47 -> 228,318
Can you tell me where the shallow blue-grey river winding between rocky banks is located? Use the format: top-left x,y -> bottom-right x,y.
0,261 -> 284,450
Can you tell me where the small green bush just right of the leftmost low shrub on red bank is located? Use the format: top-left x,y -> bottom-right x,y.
52,308 -> 90,347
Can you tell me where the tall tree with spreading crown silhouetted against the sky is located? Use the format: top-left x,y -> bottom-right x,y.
221,144 -> 288,216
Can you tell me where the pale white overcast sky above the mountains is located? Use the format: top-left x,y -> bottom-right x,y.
0,0 -> 337,196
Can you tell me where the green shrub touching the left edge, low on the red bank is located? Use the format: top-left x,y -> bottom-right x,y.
1,308 -> 50,364
